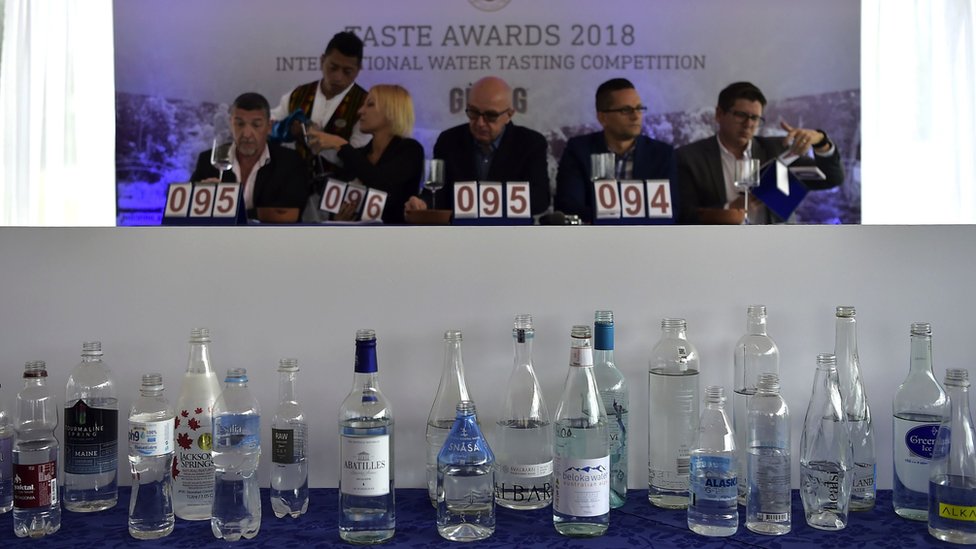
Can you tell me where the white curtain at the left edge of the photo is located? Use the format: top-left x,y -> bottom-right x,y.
0,0 -> 115,225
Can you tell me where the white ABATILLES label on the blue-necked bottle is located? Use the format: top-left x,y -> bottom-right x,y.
339,435 -> 390,496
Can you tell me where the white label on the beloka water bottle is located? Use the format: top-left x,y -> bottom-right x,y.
552,455 -> 610,517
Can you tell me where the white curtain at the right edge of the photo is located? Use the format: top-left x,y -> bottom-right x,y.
861,0 -> 976,224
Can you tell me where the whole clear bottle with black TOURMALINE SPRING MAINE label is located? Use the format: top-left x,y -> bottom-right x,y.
63,341 -> 119,512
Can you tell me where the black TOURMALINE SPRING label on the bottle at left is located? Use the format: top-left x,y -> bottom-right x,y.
64,400 -> 119,475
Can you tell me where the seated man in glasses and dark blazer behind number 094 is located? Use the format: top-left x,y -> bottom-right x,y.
553,78 -> 677,223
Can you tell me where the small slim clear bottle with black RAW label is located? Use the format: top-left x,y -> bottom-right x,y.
271,358 -> 308,518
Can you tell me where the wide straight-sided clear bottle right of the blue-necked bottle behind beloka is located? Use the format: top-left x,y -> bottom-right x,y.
647,318 -> 699,509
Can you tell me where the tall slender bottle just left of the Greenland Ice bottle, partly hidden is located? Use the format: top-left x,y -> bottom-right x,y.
834,305 -> 877,511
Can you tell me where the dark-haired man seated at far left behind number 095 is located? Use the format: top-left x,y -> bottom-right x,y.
190,93 -> 310,219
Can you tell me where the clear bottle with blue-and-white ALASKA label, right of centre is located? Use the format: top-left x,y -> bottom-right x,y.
688,385 -> 739,537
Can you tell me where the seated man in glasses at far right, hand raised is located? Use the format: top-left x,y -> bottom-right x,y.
676,82 -> 844,223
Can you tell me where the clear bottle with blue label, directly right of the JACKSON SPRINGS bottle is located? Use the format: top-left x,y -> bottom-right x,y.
210,368 -> 261,541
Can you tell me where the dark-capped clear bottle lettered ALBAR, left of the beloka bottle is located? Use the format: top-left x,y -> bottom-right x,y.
495,314 -> 552,509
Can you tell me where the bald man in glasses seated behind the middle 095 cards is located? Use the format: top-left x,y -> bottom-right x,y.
405,76 -> 550,215
